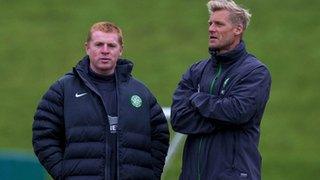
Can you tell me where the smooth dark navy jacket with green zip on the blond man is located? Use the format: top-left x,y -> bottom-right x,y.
171,42 -> 271,180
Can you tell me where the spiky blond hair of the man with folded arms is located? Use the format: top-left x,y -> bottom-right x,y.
207,0 -> 251,29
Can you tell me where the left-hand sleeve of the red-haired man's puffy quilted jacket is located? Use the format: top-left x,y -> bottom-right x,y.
32,81 -> 64,179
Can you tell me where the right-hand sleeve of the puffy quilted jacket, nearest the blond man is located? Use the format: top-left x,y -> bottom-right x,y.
150,93 -> 169,180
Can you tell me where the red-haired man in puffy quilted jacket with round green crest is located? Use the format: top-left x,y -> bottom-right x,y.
32,22 -> 169,180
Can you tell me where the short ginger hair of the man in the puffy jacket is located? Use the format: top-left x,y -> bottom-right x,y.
87,21 -> 123,46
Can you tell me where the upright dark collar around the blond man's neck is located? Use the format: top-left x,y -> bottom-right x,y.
209,41 -> 247,65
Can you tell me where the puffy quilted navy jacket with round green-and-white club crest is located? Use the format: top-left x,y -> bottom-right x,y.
33,56 -> 169,180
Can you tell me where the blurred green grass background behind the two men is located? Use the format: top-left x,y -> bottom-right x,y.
0,0 -> 320,180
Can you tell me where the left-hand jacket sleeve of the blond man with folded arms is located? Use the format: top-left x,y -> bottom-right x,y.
171,65 -> 215,134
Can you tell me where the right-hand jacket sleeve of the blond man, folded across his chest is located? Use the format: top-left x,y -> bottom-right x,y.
189,66 -> 271,125
